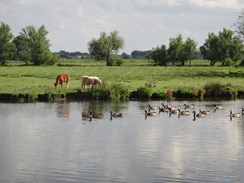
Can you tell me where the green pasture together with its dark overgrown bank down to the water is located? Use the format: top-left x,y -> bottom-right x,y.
0,60 -> 244,102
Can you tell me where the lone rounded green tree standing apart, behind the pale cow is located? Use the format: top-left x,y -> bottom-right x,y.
88,31 -> 124,66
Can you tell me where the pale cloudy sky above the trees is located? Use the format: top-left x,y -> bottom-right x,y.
0,0 -> 244,54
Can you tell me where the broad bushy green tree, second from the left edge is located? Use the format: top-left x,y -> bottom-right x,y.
15,25 -> 51,65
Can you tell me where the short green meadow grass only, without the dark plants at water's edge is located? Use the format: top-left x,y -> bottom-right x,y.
0,60 -> 244,101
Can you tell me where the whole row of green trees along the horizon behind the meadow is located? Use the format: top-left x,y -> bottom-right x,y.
0,11 -> 244,66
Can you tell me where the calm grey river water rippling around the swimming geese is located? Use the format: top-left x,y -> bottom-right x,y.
0,100 -> 244,183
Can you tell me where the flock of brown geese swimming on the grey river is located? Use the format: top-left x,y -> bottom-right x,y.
81,103 -> 244,122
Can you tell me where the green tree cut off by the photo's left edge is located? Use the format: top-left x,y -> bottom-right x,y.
0,22 -> 15,65
